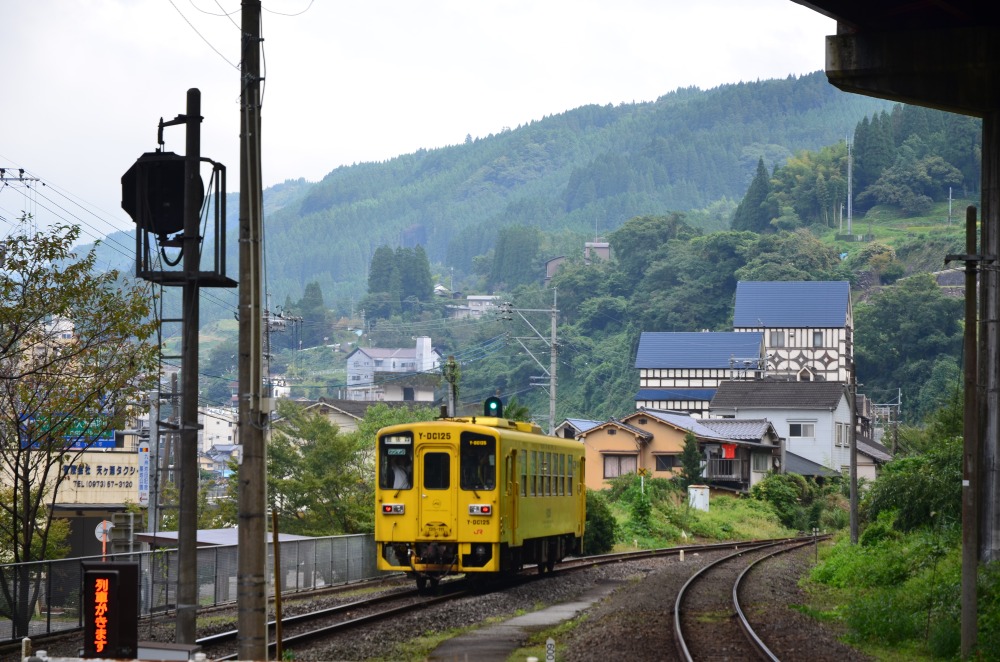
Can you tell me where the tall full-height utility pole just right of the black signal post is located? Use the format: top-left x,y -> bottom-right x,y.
236,0 -> 267,660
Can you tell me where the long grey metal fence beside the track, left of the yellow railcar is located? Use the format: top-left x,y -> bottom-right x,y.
0,535 -> 379,641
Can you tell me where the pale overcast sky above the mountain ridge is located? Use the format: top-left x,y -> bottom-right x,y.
0,0 -> 836,244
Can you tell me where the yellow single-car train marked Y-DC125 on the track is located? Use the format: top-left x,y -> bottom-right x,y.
375,416 -> 586,588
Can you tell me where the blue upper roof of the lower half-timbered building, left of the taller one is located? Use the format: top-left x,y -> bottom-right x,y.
635,331 -> 764,369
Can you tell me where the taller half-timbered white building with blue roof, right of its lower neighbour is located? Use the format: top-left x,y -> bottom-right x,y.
733,281 -> 854,383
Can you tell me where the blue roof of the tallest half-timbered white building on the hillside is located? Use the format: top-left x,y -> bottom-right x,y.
733,281 -> 851,329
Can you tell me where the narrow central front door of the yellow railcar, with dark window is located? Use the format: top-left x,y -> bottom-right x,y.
417,445 -> 458,539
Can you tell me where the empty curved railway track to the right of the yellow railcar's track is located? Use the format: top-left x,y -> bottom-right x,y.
674,538 -> 816,662
